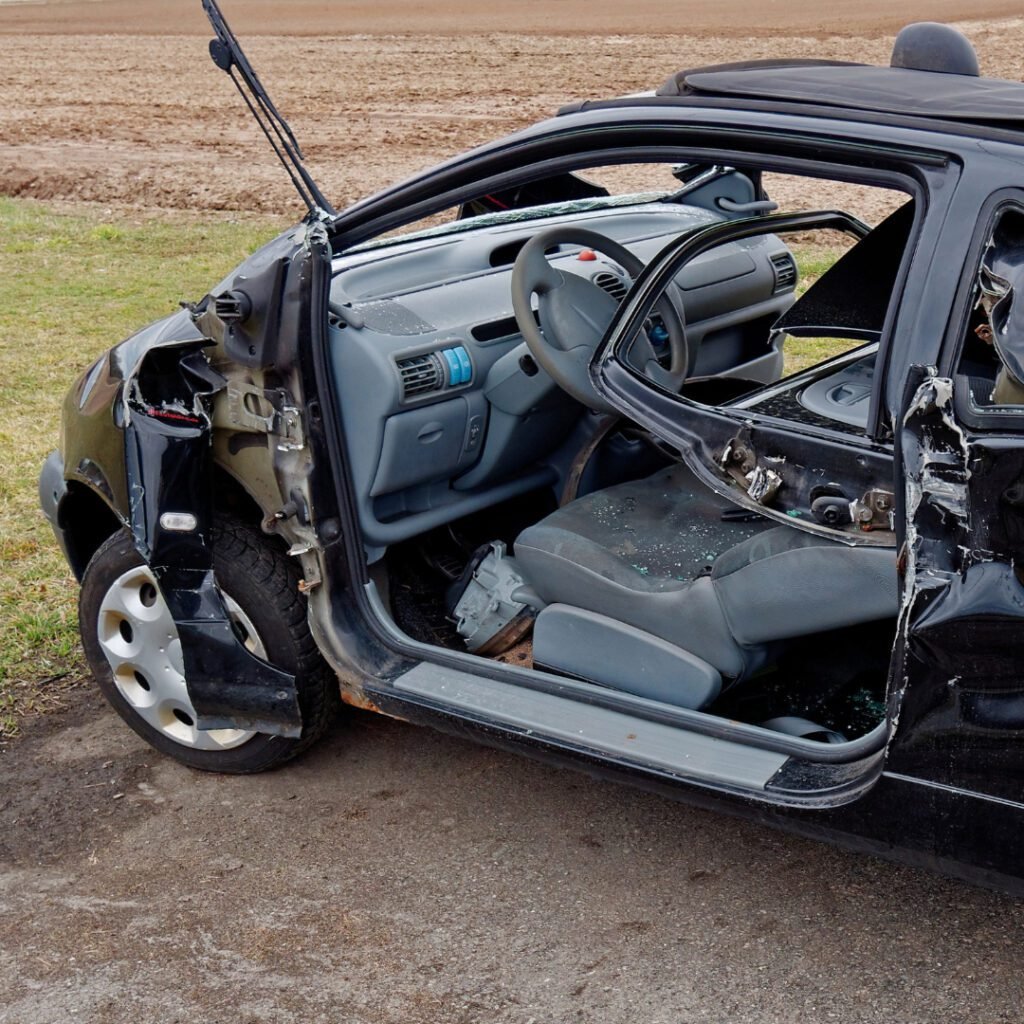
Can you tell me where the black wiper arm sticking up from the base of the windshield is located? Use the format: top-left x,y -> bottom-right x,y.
203,0 -> 337,217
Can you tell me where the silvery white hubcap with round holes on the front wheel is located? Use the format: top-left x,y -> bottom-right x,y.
96,565 -> 260,751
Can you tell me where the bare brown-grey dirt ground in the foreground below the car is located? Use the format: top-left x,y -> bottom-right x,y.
6,698 -> 1024,1024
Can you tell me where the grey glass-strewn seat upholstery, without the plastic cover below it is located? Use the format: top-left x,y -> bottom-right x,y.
515,466 -> 897,680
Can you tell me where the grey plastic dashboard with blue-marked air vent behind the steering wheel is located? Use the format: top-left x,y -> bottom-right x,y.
330,196 -> 797,553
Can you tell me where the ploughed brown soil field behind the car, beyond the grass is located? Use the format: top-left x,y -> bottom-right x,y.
0,14 -> 1024,217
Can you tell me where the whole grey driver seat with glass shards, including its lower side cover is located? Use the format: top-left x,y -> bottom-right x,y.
515,465 -> 898,709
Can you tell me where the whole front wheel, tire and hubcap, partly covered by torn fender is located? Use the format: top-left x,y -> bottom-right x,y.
79,520 -> 340,773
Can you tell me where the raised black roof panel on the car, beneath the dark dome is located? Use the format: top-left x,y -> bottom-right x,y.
655,60 -> 1024,131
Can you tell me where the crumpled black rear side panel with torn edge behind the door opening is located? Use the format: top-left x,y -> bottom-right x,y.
890,371 -> 1024,800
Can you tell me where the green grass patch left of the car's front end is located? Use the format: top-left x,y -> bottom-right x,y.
0,198 -> 287,738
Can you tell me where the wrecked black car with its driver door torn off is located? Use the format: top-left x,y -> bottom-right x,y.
40,6 -> 1024,890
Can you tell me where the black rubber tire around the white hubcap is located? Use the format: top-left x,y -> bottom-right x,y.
79,519 -> 341,774
